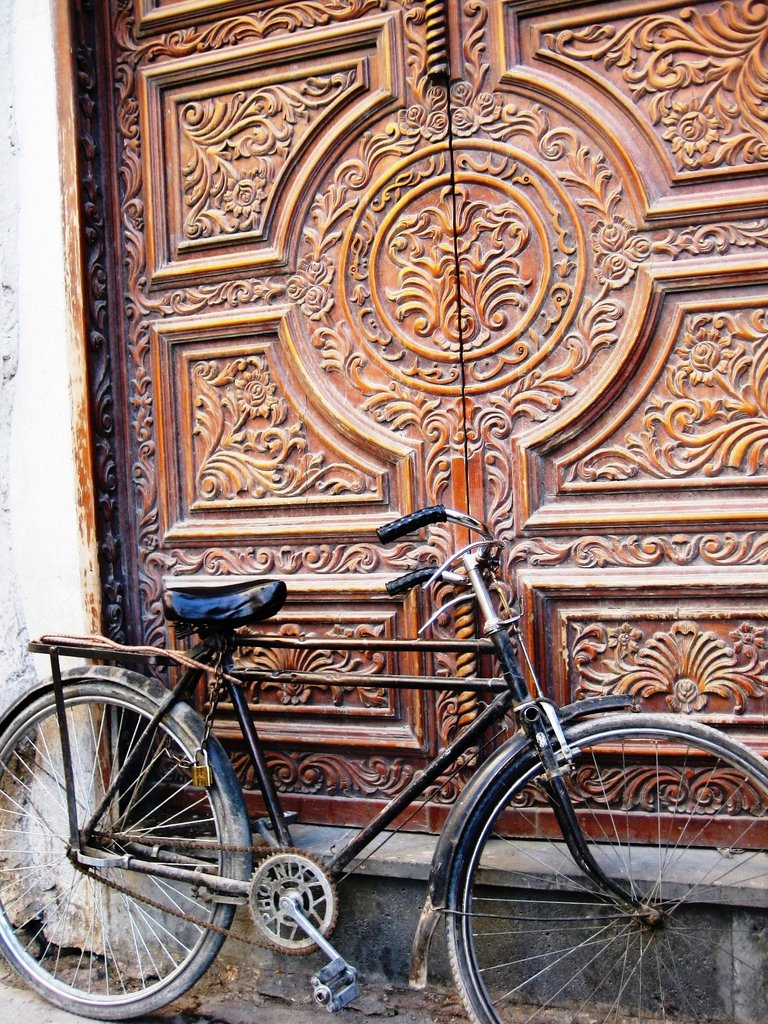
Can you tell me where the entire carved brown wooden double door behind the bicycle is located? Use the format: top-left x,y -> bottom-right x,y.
78,0 -> 768,824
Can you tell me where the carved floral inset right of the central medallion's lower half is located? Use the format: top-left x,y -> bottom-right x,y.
568,309 -> 768,481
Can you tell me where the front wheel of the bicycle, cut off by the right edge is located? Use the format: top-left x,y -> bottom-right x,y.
446,714 -> 768,1024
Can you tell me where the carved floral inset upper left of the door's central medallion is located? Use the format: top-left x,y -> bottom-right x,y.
179,72 -> 354,240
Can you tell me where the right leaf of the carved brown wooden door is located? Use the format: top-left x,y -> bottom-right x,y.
453,0 -> 768,751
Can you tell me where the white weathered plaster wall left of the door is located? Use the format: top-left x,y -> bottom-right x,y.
0,0 -> 87,708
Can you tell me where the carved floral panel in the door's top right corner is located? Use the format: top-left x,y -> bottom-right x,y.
543,0 -> 768,171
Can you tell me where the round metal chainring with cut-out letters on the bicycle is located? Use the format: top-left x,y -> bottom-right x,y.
248,849 -> 338,955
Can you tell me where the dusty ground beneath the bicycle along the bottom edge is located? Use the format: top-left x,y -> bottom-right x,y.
0,965 -> 467,1024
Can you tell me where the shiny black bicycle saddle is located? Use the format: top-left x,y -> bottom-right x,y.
163,580 -> 288,629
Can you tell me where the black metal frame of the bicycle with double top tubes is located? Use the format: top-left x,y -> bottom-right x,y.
31,528 -> 631,913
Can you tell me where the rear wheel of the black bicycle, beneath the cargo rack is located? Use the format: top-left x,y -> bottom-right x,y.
0,668 -> 252,1020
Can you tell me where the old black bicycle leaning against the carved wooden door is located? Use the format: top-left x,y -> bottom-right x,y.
0,506 -> 768,1024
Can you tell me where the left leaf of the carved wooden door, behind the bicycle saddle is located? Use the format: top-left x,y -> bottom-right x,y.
76,0 -> 475,821
